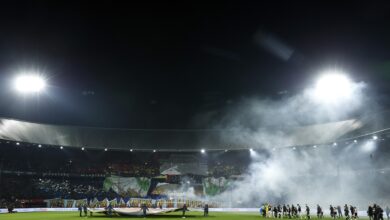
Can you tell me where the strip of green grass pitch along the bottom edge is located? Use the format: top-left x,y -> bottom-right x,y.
0,212 -> 360,220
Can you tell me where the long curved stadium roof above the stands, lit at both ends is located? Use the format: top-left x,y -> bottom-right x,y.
0,118 -> 384,151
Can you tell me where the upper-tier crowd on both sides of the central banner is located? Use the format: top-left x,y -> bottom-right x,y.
0,142 -> 248,178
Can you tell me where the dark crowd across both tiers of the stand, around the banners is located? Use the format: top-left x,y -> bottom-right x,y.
0,140 -> 247,207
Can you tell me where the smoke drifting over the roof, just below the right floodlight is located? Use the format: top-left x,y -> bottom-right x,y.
209,78 -> 373,149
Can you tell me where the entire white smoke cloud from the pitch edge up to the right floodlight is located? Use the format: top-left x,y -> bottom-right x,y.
198,78 -> 380,207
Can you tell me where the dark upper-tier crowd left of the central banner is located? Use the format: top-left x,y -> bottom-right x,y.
0,144 -> 159,177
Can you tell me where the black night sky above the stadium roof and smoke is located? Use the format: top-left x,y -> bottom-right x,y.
0,1 -> 390,129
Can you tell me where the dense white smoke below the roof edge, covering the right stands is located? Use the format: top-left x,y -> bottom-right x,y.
215,143 -> 376,207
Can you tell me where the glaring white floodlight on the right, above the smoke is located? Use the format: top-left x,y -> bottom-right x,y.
314,70 -> 353,103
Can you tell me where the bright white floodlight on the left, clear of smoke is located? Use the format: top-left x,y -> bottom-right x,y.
14,73 -> 46,94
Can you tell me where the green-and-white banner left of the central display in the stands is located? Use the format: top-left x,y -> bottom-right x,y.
103,176 -> 150,197
